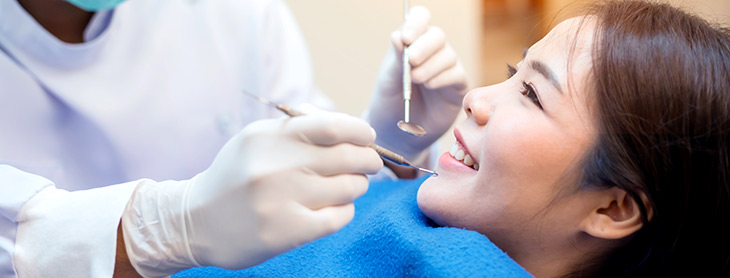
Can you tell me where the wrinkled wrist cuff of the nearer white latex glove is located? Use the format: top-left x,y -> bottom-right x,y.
122,180 -> 199,277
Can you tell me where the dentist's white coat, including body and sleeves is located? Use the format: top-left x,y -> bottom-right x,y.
0,0 -> 331,277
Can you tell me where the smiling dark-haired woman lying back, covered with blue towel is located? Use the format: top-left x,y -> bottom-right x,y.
178,1 -> 730,277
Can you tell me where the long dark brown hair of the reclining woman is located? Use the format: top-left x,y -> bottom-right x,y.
576,1 -> 730,277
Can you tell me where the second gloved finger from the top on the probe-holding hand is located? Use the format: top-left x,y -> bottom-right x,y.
307,144 -> 383,176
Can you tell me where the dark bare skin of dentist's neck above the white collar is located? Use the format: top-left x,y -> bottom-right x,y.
18,0 -> 94,43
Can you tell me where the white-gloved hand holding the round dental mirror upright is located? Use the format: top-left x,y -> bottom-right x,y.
365,6 -> 467,162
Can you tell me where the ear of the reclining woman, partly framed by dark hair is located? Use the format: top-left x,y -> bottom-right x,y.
581,187 -> 652,239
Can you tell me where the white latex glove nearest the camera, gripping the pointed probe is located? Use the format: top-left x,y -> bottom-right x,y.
122,112 -> 383,276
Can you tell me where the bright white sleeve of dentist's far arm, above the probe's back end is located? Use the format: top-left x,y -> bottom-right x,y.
261,0 -> 335,111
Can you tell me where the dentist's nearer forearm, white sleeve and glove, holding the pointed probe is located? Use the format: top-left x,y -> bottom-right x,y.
5,112 -> 382,277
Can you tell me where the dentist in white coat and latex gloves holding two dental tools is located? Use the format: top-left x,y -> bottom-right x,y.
0,0 -> 466,277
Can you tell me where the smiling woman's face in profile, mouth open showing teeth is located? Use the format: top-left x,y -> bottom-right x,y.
418,18 -> 596,262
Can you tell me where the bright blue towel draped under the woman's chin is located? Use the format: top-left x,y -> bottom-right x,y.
173,178 -> 532,278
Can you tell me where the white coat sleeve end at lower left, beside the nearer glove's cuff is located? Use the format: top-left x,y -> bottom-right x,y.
0,165 -> 137,277
